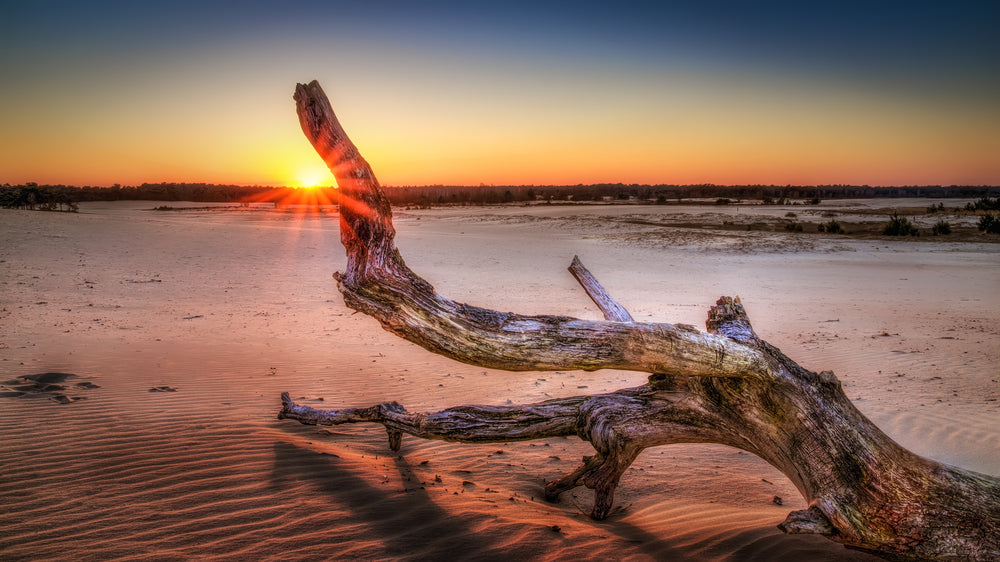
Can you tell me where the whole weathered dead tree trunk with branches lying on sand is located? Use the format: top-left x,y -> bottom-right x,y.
280,82 -> 1000,560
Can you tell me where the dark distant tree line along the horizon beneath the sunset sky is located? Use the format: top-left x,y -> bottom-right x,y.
0,182 -> 1000,211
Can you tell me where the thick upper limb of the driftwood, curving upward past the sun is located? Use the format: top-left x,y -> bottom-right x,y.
295,81 -> 765,376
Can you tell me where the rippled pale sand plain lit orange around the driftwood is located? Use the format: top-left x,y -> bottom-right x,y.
0,201 -> 1000,560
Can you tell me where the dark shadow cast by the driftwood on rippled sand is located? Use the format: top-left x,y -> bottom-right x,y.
270,424 -> 875,560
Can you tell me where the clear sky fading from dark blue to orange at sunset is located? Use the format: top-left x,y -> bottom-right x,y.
0,0 -> 1000,185
